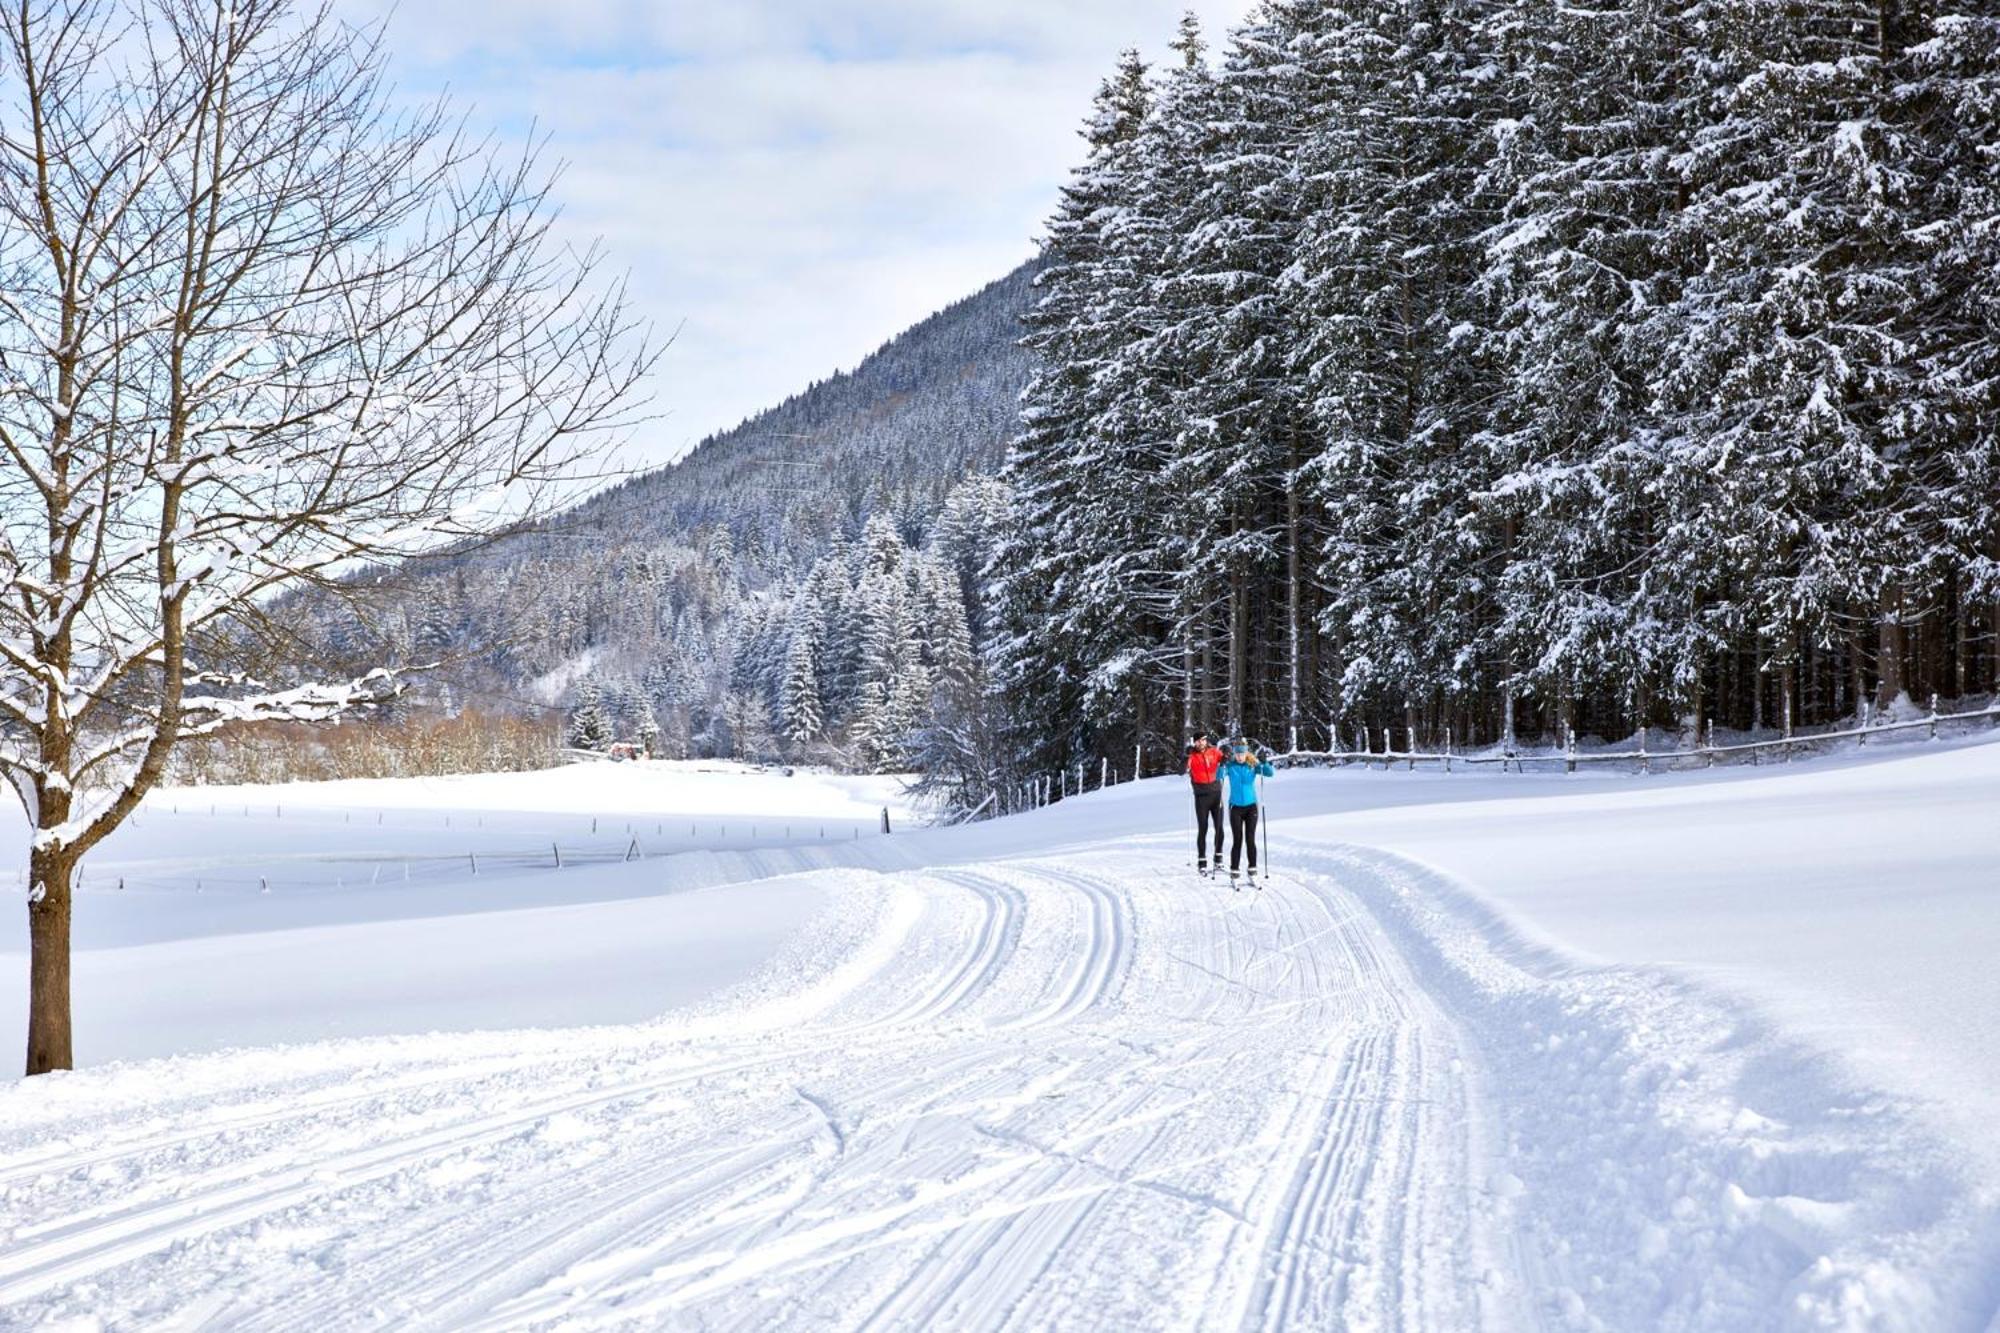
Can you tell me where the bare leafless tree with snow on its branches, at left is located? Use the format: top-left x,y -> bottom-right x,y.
0,0 -> 652,1075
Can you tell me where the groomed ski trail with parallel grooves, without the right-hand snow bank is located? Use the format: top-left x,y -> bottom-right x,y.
0,843 -> 1506,1329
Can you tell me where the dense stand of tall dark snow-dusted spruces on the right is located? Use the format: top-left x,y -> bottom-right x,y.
988,0 -> 2000,780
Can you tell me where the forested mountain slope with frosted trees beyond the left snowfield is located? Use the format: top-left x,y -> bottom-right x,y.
274,264 -> 1034,759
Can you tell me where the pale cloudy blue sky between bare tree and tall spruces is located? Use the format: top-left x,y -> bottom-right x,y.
342,0 -> 1250,466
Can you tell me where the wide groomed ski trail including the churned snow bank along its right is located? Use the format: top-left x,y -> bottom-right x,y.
0,839 -> 1992,1333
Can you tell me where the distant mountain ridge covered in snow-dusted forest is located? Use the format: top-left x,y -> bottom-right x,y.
274,260 -> 1038,753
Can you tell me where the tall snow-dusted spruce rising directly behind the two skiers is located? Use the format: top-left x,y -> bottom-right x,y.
1162,0 -> 1336,743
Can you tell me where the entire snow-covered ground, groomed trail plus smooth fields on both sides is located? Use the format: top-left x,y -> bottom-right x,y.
0,743 -> 2000,1329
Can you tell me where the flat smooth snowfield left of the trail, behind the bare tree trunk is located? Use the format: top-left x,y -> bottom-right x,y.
0,763 -> 912,1065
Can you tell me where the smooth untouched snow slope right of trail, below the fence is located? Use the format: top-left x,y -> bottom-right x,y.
1272,743 -> 2000,1175
